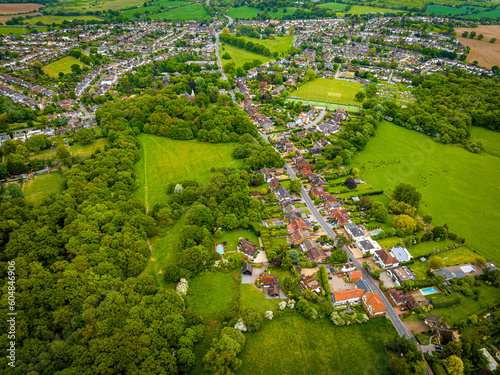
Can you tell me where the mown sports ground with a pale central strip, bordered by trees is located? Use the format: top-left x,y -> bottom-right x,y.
290,78 -> 363,104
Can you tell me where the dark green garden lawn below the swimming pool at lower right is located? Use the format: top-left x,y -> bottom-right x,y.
405,281 -> 499,326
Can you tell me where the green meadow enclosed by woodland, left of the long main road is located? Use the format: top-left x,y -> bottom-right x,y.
135,133 -> 243,212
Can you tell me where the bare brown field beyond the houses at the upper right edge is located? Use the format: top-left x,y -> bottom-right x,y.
455,25 -> 500,69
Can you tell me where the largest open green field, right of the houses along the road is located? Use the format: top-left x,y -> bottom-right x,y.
352,122 -> 500,263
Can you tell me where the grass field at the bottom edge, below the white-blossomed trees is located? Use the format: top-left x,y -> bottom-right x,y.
236,312 -> 396,375
